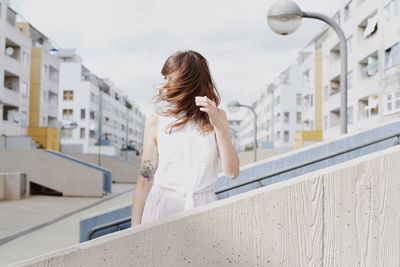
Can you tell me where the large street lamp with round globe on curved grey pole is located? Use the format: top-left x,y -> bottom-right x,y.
267,0 -> 347,134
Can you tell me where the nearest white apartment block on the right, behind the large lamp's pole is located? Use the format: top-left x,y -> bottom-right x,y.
322,0 -> 400,140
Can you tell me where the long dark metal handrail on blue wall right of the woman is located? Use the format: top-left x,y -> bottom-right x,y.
215,133 -> 400,194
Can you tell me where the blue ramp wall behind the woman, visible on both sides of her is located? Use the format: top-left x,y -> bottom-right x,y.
76,121 -> 400,245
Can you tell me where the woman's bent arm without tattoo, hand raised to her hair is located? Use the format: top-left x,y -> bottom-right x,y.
196,96 -> 240,179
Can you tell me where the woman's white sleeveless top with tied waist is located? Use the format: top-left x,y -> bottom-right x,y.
153,115 -> 219,210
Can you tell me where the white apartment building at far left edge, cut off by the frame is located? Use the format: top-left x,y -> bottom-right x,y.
0,0 -> 32,136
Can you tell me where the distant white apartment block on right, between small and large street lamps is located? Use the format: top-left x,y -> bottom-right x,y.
238,62 -> 301,150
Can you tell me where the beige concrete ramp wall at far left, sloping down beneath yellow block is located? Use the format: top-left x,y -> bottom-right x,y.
0,149 -> 103,197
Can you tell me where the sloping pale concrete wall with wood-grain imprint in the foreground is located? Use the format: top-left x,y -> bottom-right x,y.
10,147 -> 400,266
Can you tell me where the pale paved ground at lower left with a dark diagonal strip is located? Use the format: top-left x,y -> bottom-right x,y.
0,184 -> 135,266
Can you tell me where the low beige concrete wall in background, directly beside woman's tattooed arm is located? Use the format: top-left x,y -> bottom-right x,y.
68,153 -> 139,183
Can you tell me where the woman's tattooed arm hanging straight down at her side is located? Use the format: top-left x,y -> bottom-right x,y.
131,114 -> 158,226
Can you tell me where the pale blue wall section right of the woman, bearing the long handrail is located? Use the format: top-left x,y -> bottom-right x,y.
215,120 -> 400,199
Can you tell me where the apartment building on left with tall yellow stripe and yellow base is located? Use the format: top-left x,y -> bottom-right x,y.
17,22 -> 60,150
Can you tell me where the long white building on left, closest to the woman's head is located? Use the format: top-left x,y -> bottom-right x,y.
59,50 -> 145,155
